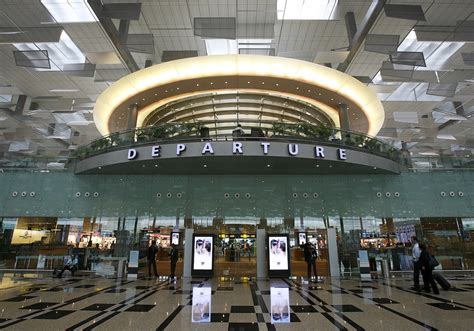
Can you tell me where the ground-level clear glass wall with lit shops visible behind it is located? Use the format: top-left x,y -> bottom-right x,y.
0,215 -> 474,276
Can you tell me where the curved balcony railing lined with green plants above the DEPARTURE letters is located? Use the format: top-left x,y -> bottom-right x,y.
74,122 -> 405,163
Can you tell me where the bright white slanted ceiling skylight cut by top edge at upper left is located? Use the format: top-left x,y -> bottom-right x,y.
41,0 -> 98,23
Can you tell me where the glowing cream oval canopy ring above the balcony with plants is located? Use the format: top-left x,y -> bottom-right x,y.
94,55 -> 385,135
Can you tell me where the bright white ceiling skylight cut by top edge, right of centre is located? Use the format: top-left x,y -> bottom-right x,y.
277,0 -> 338,20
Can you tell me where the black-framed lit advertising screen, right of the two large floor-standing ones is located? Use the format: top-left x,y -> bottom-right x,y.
268,235 -> 290,277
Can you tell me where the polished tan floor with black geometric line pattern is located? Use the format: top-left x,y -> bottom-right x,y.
0,274 -> 474,331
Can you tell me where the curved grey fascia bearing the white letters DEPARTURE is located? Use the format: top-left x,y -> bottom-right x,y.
76,138 -> 400,174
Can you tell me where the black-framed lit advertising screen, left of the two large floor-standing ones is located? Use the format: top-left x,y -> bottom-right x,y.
192,235 -> 214,276
